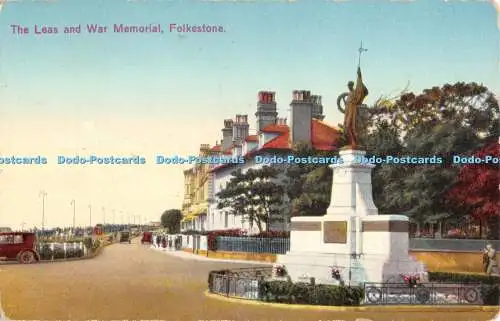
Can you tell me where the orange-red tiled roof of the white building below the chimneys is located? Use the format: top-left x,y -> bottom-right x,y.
211,119 -> 340,171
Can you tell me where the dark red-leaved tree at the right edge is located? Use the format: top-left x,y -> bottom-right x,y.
447,139 -> 500,239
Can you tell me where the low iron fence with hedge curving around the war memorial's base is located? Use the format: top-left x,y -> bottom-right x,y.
208,267 -> 492,305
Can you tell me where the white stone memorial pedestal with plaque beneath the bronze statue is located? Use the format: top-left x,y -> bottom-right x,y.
277,150 -> 426,284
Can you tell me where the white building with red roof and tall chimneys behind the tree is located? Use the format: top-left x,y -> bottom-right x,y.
188,90 -> 339,234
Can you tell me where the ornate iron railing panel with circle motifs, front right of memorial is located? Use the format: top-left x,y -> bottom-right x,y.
364,283 -> 483,305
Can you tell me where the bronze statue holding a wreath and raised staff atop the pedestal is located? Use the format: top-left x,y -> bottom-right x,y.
337,45 -> 368,149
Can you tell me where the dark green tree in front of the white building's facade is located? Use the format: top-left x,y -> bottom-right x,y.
217,166 -> 284,232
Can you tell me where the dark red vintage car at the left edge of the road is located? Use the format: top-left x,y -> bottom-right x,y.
0,232 -> 40,264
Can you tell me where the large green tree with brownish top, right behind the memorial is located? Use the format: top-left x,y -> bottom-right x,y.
362,83 -> 499,220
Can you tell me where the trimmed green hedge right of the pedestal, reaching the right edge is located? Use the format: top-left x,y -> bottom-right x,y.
429,272 -> 500,306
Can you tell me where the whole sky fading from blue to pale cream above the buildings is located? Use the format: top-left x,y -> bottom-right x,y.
0,0 -> 500,229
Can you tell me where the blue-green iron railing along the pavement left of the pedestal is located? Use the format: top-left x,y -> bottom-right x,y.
216,236 -> 290,254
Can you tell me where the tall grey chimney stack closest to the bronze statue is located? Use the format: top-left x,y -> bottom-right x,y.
290,90 -> 314,144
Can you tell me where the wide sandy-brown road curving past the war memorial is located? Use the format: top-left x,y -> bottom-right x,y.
0,243 -> 493,321
